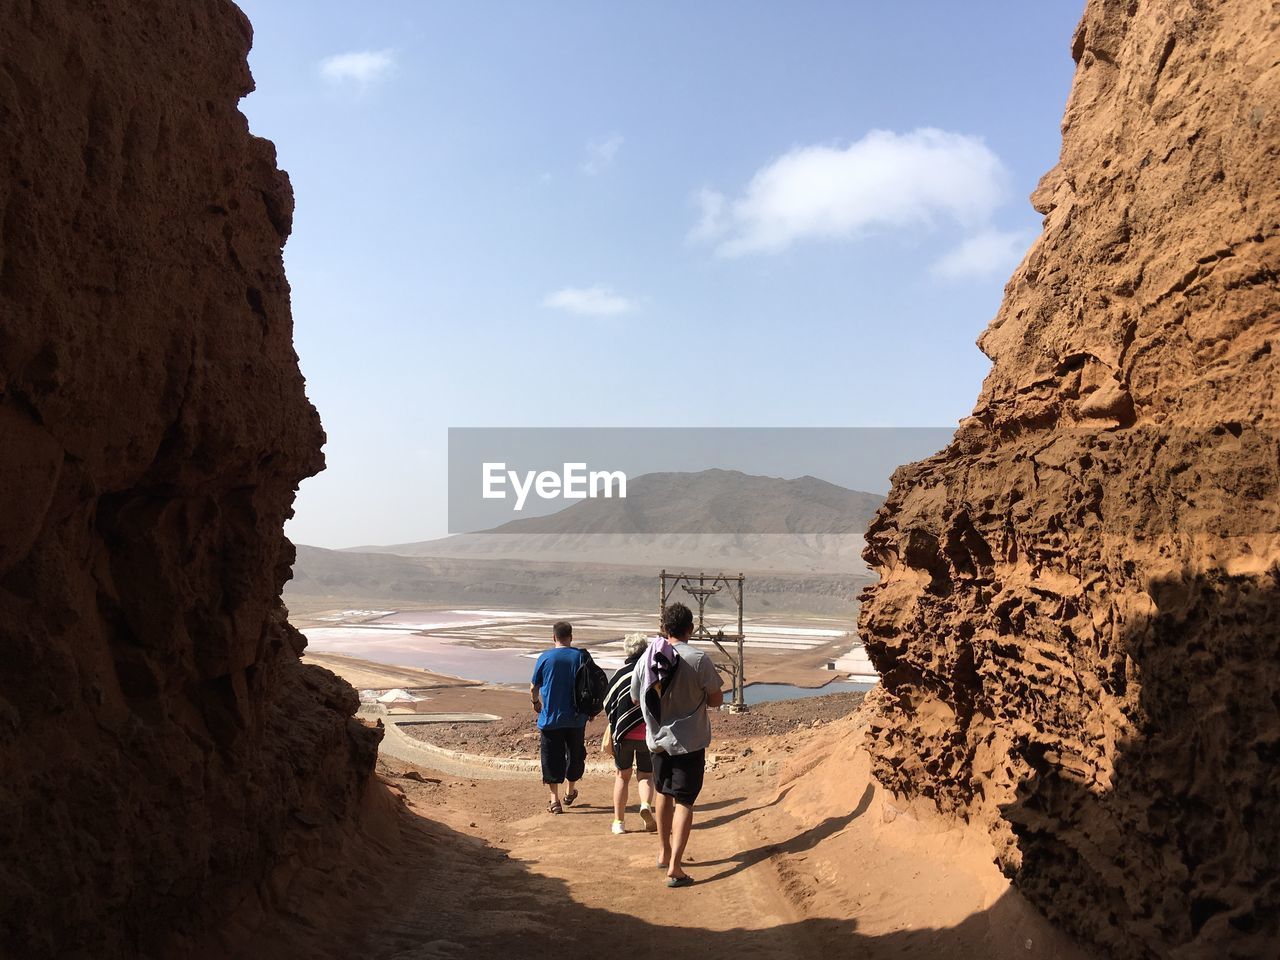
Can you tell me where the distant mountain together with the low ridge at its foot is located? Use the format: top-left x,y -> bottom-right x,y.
287,470 -> 883,614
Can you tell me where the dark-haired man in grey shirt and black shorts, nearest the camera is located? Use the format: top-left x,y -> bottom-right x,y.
631,603 -> 724,887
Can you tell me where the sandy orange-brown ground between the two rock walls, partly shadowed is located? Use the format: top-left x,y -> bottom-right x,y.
327,712 -> 1089,960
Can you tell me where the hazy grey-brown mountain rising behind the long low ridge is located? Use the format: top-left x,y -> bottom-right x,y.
352,470 -> 884,573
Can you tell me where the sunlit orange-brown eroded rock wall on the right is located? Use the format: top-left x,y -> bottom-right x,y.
860,0 -> 1280,957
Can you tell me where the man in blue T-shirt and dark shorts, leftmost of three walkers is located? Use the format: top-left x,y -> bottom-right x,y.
529,620 -> 588,813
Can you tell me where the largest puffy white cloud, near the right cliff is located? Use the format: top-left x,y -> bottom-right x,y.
690,128 -> 1006,257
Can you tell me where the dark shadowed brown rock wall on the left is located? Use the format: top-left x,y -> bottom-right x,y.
0,0 -> 379,957
